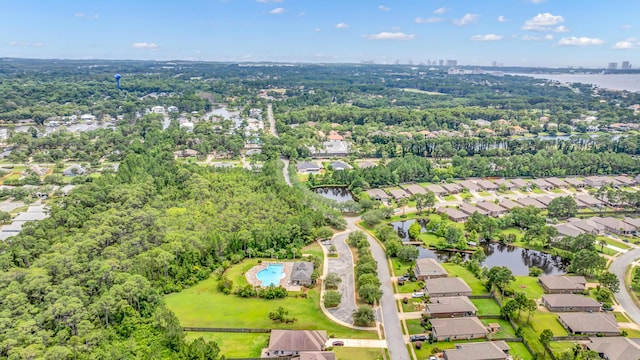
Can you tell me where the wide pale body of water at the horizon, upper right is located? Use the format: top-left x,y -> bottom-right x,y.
512,74 -> 640,92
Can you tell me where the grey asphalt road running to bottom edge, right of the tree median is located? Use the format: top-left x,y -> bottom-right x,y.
346,218 -> 411,360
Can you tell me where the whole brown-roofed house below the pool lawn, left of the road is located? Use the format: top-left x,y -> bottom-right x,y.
262,329 -> 329,358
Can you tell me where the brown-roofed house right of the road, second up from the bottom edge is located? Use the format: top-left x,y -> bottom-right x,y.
430,317 -> 489,341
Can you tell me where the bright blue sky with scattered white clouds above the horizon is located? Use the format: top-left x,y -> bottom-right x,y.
0,0 -> 640,67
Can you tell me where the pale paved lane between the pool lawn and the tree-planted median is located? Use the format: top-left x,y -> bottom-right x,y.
322,230 -> 358,324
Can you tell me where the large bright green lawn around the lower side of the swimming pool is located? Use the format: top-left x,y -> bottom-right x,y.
165,263 -> 377,339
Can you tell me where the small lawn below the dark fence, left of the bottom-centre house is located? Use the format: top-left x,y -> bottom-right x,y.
186,332 -> 269,358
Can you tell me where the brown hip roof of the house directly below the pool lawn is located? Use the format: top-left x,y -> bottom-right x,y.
269,329 -> 328,351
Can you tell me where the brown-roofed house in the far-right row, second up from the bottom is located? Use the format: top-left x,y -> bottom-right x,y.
558,312 -> 620,336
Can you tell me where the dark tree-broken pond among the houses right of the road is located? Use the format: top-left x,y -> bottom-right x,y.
389,219 -> 568,275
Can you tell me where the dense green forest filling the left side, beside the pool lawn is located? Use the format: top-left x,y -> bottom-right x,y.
0,122 -> 336,359
